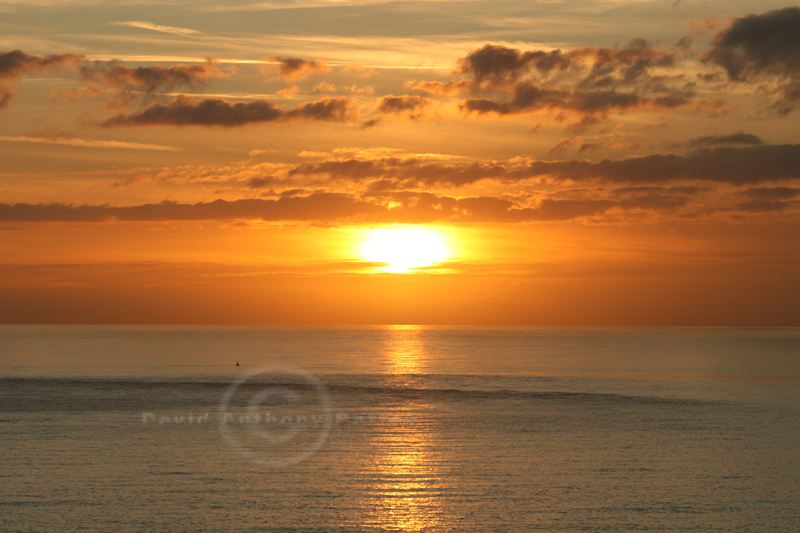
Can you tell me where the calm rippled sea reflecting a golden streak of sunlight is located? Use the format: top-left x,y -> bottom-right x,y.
0,326 -> 800,532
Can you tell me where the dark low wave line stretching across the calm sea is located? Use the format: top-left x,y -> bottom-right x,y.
0,375 -> 721,412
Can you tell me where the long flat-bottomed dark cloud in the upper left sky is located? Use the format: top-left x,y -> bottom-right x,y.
100,95 -> 354,127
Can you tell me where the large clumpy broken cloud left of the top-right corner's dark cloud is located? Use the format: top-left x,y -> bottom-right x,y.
440,38 -> 694,129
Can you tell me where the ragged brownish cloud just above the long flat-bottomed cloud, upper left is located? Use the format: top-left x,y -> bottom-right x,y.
78,60 -> 224,102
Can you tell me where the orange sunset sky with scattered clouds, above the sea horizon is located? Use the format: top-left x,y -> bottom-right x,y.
0,0 -> 800,326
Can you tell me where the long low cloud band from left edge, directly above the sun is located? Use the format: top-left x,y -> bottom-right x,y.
0,191 -> 618,224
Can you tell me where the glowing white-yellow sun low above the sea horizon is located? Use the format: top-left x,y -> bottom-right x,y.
361,228 -> 450,273
